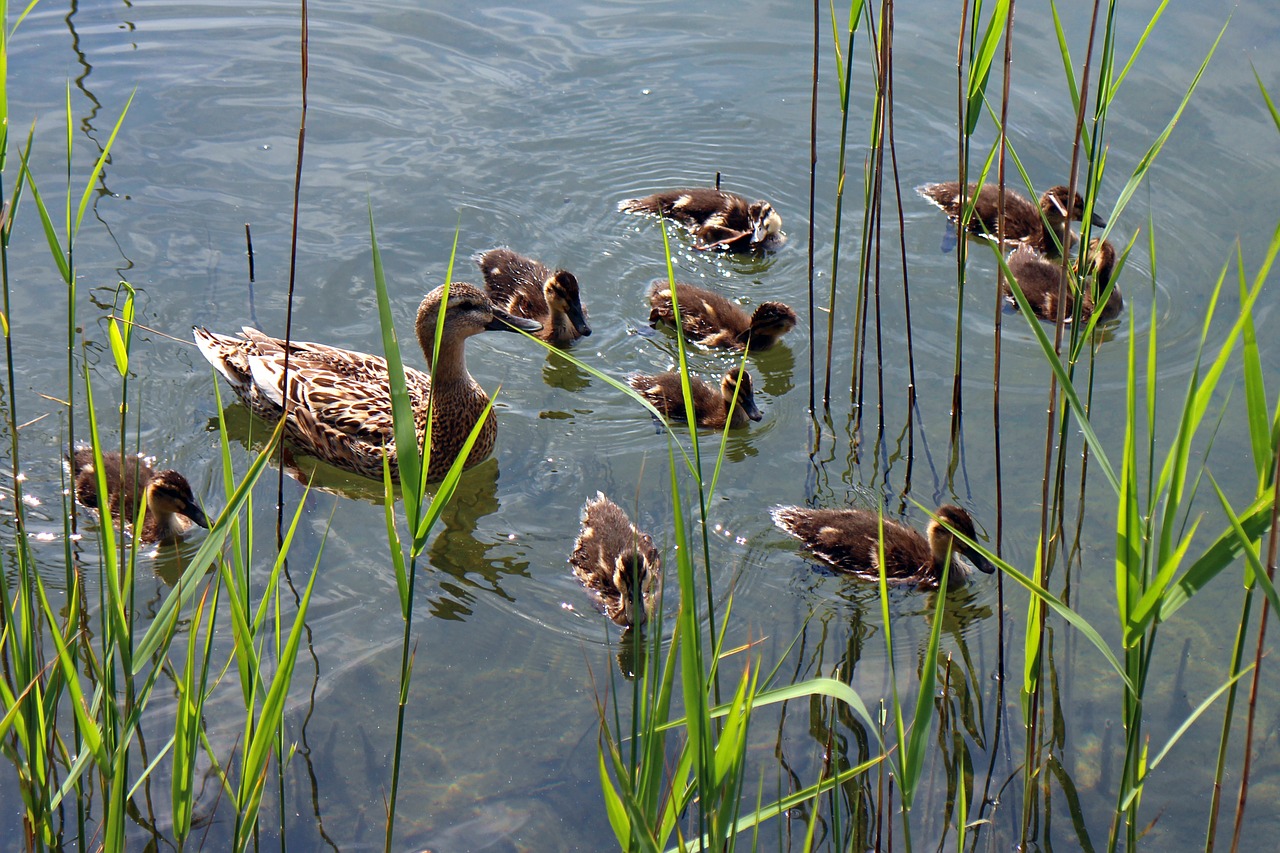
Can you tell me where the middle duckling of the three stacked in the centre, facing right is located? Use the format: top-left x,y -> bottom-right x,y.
649,279 -> 796,350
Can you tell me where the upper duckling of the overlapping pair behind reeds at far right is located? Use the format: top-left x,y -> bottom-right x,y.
915,181 -> 1107,256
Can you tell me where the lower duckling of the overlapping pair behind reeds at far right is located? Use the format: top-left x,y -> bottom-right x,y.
1004,238 -> 1124,323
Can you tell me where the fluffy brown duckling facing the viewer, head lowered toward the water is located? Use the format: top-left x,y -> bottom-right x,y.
568,492 -> 662,628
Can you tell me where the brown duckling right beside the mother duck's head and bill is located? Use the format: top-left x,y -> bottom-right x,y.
472,248 -> 591,347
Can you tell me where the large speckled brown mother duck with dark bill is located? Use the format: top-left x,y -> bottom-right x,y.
193,282 -> 541,482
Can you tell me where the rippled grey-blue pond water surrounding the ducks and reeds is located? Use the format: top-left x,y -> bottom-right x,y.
0,0 -> 1280,853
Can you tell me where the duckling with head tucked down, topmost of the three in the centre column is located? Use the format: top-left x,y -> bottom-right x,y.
618,187 -> 787,252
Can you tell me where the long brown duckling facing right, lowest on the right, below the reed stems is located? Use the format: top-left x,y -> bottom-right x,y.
771,503 -> 995,589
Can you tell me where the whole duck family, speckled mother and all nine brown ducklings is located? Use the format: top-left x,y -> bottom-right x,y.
70,172 -> 1123,612
